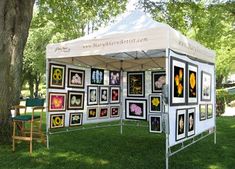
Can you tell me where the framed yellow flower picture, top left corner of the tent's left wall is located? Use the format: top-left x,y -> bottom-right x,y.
49,63 -> 66,89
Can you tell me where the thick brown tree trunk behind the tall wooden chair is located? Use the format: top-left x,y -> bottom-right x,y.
0,0 -> 35,142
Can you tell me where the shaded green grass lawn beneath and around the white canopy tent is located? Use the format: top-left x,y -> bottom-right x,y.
0,117 -> 235,169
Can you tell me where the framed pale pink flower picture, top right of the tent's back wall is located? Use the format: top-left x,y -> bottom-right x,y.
151,71 -> 166,93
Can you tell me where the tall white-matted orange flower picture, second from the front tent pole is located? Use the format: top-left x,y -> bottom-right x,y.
187,63 -> 198,104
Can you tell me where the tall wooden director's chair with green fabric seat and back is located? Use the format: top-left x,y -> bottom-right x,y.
12,99 -> 45,154
